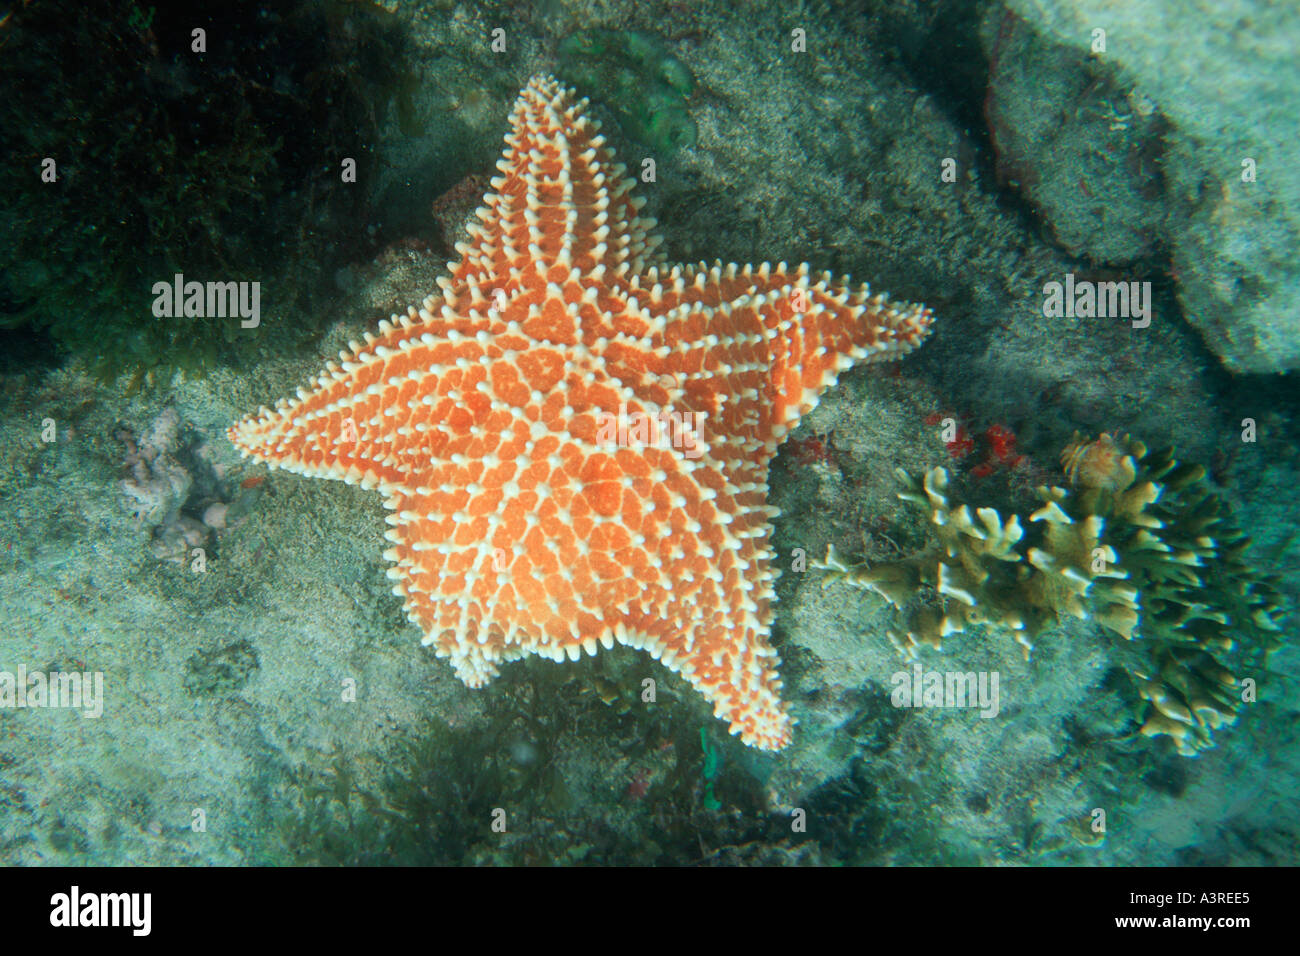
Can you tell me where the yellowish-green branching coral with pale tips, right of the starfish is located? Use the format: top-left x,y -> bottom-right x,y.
820,434 -> 1281,754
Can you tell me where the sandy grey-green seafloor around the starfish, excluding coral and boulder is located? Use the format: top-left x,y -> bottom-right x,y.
0,3 -> 1300,865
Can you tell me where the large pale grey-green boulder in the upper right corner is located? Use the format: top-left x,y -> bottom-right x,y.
980,0 -> 1300,373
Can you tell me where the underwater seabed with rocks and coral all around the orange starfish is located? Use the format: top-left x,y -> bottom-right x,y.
0,0 -> 1300,865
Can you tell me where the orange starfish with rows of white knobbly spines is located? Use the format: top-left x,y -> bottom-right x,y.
229,77 -> 932,749
